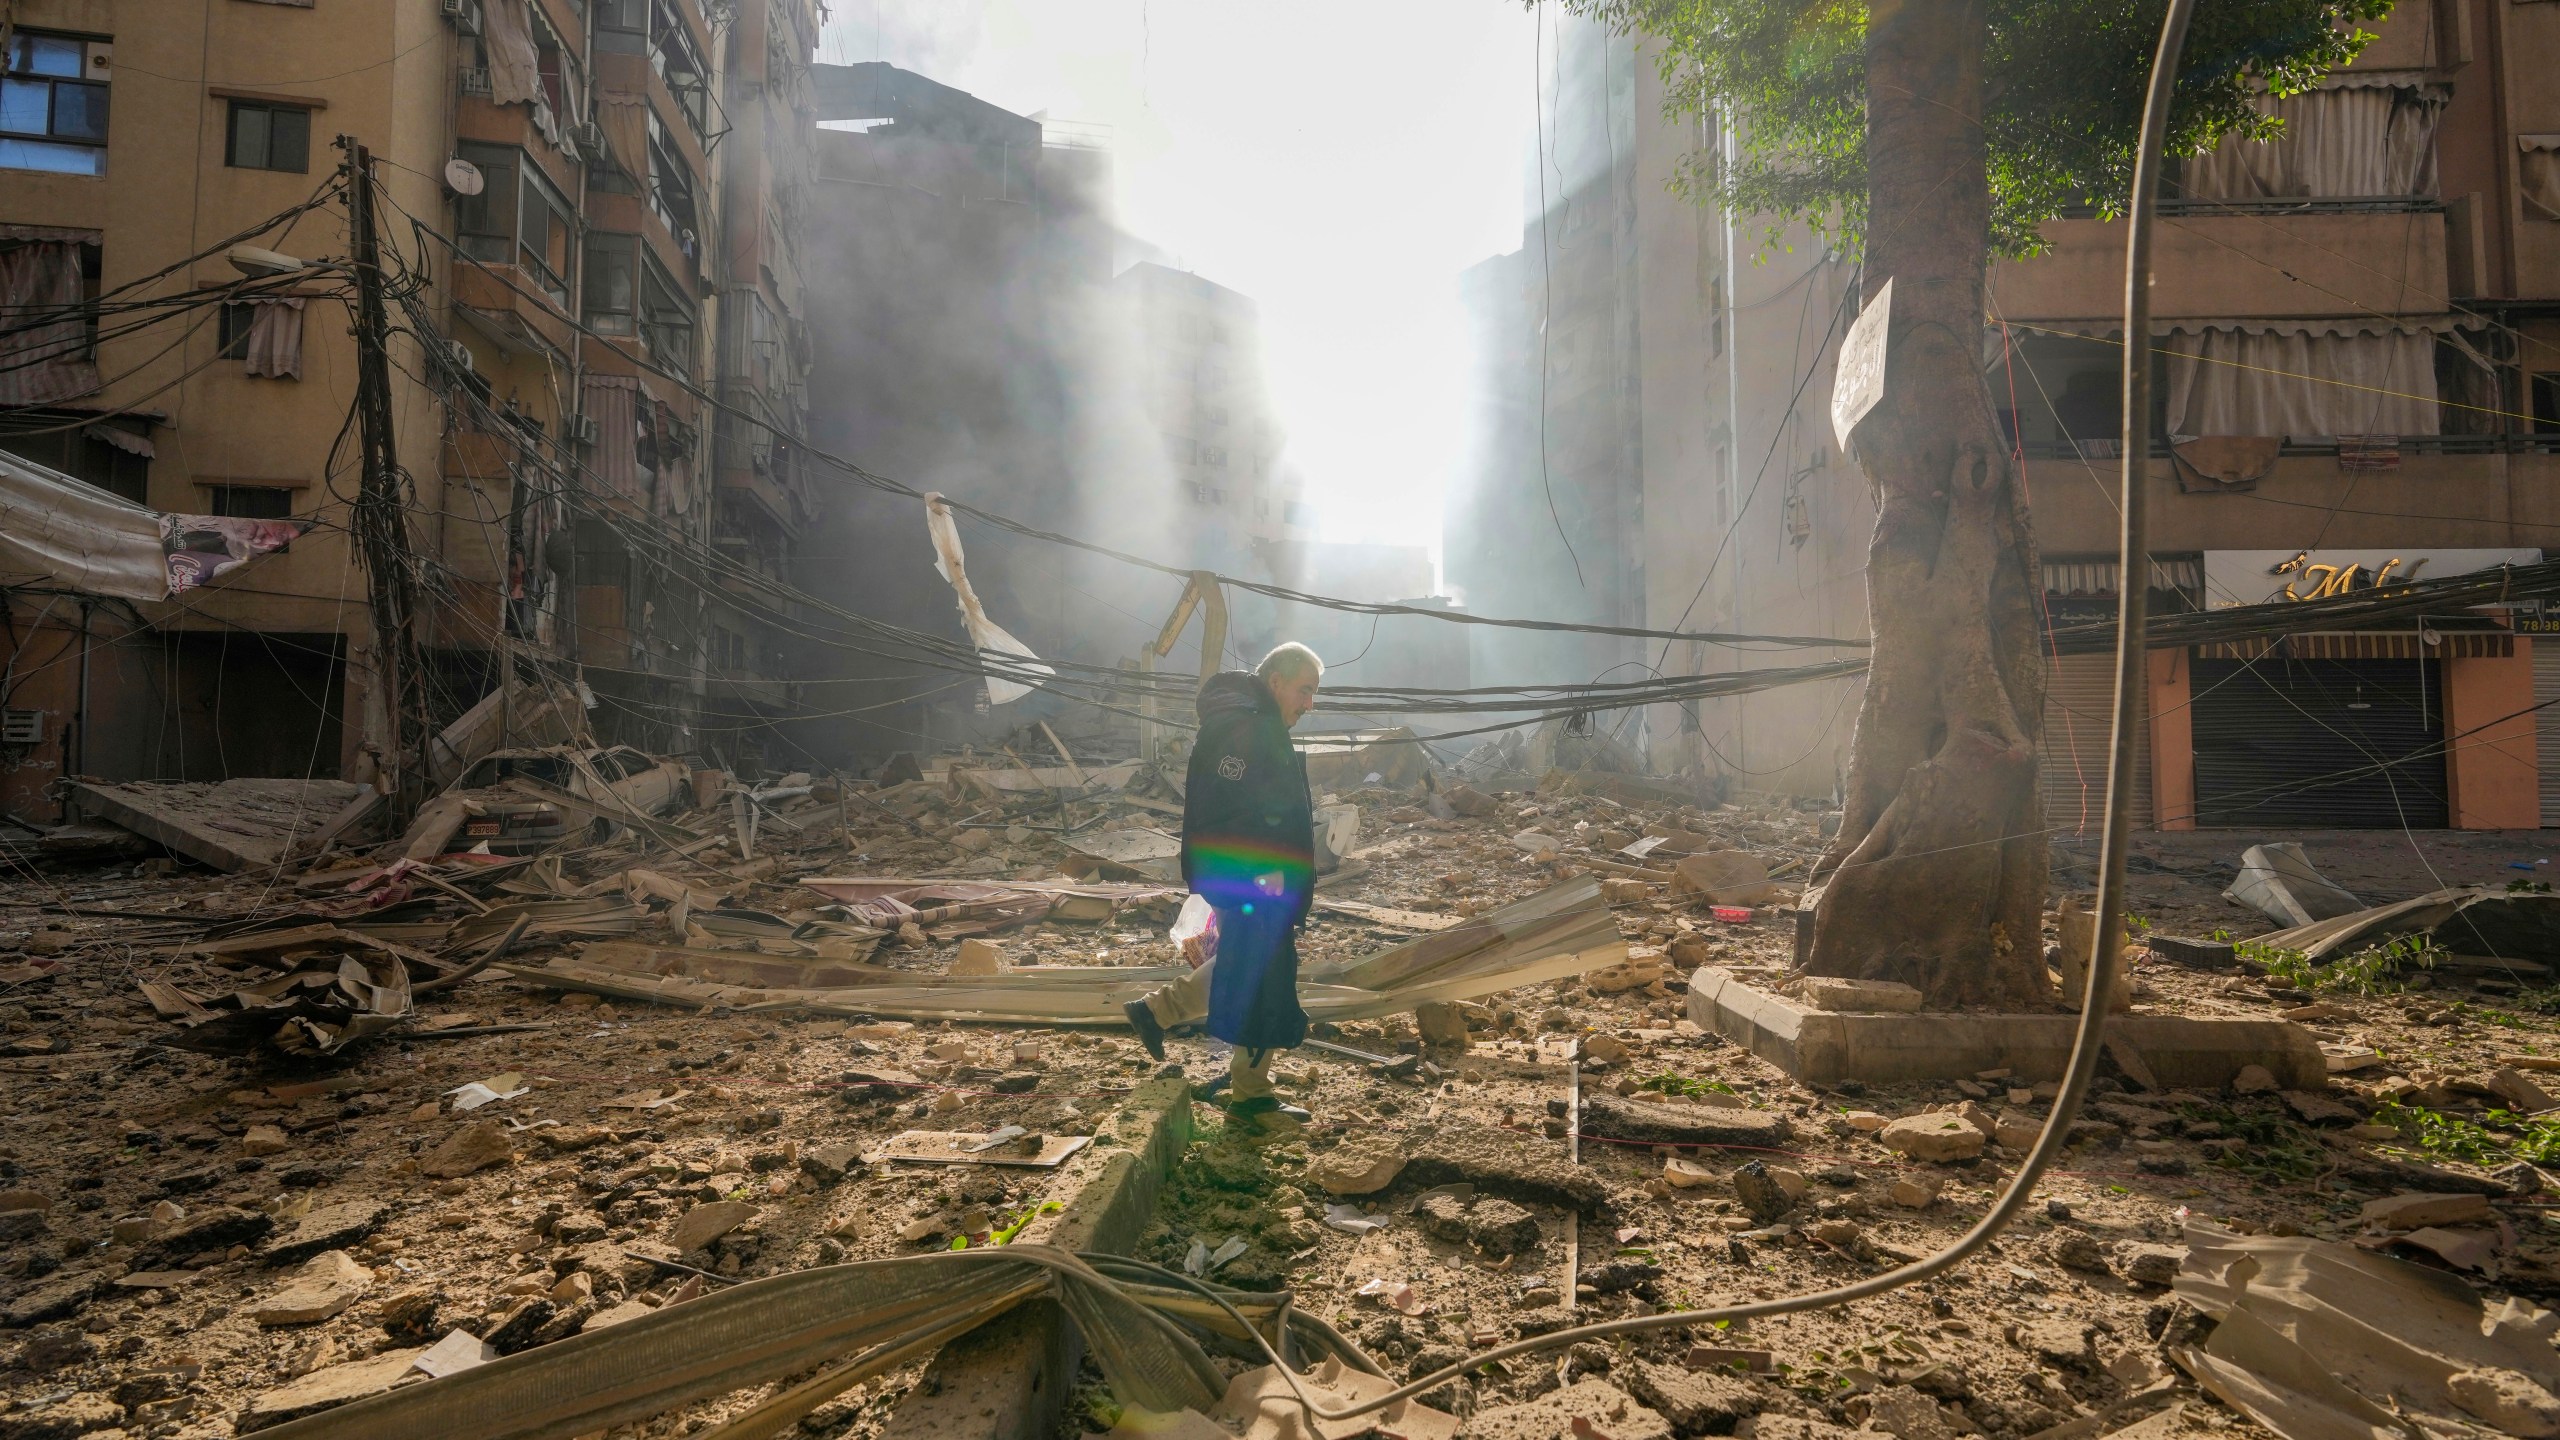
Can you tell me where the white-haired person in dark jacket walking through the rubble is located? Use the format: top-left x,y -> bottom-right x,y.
1126,641 -> 1324,1135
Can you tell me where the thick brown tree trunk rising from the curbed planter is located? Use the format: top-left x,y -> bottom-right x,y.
1807,0 -> 2053,1010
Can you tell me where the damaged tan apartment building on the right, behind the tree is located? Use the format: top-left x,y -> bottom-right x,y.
1446,0 -> 2560,838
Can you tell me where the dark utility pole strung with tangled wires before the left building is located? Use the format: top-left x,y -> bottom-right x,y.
338,136 -> 430,825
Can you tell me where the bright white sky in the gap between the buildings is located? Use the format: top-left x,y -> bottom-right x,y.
819,0 -> 1533,556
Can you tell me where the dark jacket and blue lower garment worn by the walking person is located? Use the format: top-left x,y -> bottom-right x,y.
1183,671 -> 1316,1048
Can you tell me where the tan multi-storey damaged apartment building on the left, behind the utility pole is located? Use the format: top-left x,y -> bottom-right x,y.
0,0 -> 819,820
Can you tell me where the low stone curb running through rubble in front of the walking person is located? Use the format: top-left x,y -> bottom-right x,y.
888,1076 -> 1190,1440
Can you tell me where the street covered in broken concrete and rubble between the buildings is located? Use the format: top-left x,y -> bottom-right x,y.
15,753 -> 2560,1440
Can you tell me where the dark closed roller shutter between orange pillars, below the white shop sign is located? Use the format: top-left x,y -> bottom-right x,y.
2189,659 -> 2447,830
